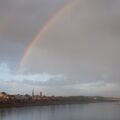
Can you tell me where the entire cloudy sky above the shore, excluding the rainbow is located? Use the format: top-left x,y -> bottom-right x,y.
0,0 -> 120,96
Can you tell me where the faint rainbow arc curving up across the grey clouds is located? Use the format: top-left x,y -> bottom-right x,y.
18,0 -> 78,69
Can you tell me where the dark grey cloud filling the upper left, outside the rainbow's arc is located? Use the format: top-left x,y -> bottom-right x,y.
0,0 -> 68,64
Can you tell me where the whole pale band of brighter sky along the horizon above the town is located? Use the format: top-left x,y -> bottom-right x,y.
0,63 -> 119,95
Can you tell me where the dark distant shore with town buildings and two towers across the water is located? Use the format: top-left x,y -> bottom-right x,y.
0,89 -> 120,107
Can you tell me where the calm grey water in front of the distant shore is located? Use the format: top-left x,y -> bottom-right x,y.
0,103 -> 120,120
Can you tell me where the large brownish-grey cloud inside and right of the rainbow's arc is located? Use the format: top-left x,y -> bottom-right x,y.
18,0 -> 120,94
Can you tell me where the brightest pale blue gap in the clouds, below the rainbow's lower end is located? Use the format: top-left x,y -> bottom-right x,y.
0,63 -> 65,86
